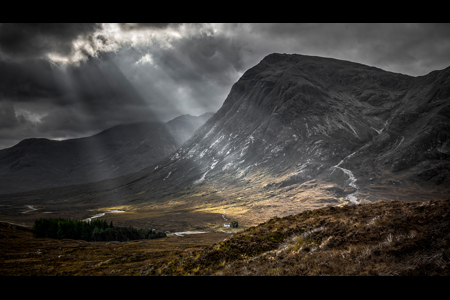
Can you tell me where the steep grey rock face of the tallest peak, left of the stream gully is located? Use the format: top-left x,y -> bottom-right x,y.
154,54 -> 428,184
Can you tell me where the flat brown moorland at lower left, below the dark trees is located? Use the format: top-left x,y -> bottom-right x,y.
0,223 -> 230,276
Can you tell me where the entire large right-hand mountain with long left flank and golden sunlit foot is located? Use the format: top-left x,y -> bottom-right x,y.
1,53 -> 450,230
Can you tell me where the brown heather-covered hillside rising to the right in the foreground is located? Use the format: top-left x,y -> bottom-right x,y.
142,199 -> 450,276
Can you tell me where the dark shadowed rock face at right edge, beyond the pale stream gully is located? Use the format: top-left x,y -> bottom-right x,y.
326,68 -> 450,192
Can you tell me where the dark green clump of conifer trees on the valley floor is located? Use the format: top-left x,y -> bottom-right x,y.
33,218 -> 166,242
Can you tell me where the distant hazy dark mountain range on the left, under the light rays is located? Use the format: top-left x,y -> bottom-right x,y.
0,113 -> 212,193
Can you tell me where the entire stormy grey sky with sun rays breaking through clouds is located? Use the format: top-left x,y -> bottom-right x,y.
0,23 -> 450,149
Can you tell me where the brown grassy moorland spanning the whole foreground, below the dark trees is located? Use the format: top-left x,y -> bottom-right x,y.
0,199 -> 450,276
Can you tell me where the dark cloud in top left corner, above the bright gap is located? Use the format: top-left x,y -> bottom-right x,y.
0,23 -> 101,59
